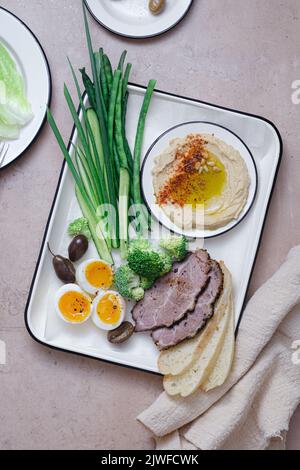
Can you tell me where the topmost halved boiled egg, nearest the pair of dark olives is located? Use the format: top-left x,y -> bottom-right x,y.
76,259 -> 114,295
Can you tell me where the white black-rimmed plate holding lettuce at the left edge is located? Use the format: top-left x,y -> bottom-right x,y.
0,7 -> 51,169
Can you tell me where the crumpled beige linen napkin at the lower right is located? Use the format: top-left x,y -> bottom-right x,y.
138,246 -> 300,450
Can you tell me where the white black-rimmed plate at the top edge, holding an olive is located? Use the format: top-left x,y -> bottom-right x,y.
85,0 -> 193,38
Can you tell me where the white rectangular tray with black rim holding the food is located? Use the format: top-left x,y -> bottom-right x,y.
25,85 -> 282,372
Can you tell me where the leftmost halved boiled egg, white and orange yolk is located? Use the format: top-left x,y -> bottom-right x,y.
55,284 -> 92,324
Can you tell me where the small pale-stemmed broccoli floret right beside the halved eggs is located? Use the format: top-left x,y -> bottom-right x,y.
114,264 -> 145,302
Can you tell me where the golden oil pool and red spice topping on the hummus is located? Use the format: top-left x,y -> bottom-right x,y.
157,135 -> 226,208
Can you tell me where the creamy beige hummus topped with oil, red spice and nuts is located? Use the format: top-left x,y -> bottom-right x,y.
152,133 -> 251,230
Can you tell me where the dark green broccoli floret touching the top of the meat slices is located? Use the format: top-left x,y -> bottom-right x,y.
127,247 -> 164,279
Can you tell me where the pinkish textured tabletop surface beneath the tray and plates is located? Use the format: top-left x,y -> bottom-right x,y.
0,0 -> 300,449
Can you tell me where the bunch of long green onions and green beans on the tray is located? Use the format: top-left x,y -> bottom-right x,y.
47,1 -> 156,263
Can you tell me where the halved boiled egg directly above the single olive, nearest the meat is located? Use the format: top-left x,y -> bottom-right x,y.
92,290 -> 126,331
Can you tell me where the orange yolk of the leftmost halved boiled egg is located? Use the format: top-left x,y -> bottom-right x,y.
58,291 -> 91,323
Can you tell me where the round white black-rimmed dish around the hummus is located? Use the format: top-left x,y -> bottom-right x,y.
142,121 -> 257,238
